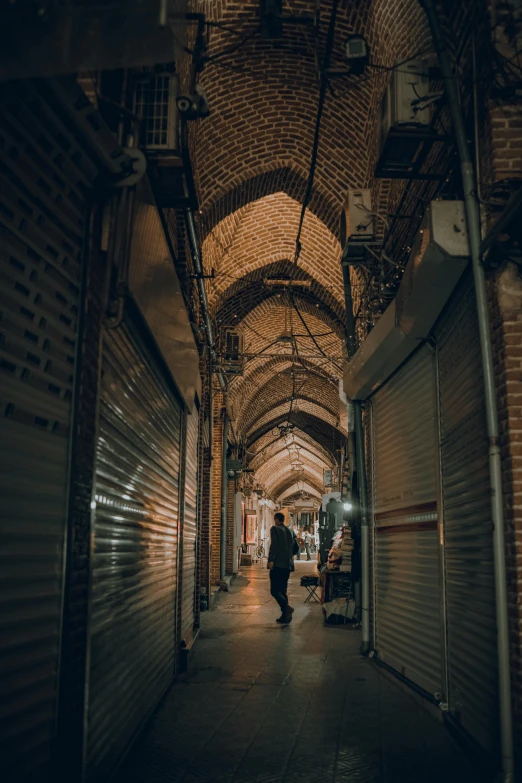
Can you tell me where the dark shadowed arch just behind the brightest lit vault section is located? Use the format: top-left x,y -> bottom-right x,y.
215,259 -> 345,328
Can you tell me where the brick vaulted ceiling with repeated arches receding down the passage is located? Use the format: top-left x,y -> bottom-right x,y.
185,0 -> 428,497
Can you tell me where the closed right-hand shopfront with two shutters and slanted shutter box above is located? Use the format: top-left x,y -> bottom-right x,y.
345,202 -> 498,755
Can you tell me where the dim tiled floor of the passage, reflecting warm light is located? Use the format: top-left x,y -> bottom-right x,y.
118,561 -> 486,783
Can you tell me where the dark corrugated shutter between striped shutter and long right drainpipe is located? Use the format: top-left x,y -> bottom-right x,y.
437,281 -> 498,751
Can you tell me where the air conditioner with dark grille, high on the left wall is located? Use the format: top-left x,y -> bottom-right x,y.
134,72 -> 179,151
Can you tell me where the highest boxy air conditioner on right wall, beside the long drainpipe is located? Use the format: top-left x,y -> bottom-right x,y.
380,60 -> 431,170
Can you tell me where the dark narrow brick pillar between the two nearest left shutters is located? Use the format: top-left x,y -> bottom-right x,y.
54,198 -> 105,780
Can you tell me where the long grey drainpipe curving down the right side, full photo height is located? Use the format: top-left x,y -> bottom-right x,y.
420,0 -> 514,783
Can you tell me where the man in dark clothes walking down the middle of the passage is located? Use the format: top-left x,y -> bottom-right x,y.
268,512 -> 298,624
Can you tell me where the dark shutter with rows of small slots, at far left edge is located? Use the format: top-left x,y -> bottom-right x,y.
0,82 -> 98,781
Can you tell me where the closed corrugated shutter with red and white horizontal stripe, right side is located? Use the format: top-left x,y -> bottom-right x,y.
372,347 -> 444,694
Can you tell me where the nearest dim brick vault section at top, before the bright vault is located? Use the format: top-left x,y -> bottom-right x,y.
187,0 -> 428,230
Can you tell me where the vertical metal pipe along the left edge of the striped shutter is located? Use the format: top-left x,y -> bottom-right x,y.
353,402 -> 370,655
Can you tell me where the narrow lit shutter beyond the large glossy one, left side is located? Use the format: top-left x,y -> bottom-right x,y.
181,409 -> 199,644
